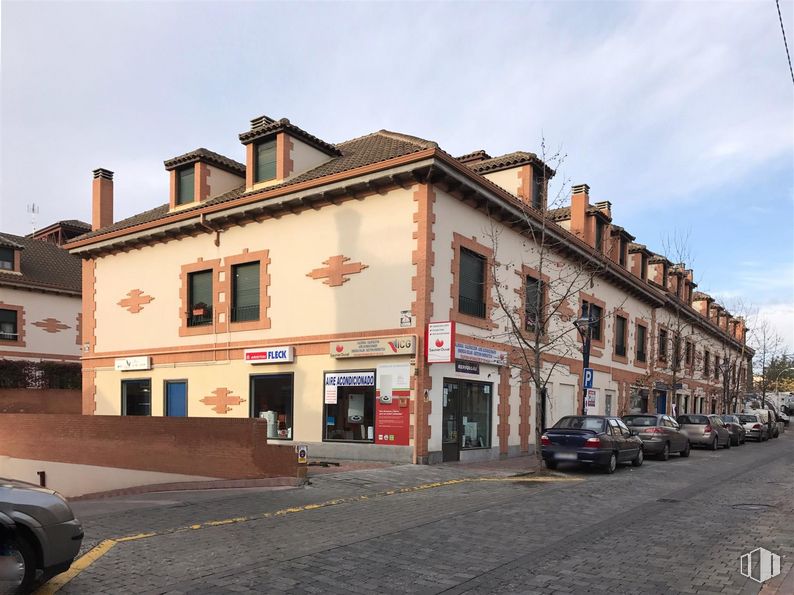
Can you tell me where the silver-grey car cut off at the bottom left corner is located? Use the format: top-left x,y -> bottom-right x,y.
0,478 -> 83,593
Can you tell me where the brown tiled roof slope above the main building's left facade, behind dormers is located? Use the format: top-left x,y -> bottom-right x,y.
73,130 -> 438,241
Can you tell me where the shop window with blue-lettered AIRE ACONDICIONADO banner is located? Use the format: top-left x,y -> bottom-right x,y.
323,370 -> 375,442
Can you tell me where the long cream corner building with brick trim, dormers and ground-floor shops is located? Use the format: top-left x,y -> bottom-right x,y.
68,116 -> 750,463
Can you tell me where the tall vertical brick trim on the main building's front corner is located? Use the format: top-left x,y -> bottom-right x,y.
410,184 -> 436,463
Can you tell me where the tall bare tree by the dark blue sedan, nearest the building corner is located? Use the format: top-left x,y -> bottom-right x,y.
488,140 -> 608,460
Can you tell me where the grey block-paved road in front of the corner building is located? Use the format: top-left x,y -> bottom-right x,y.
52,431 -> 794,595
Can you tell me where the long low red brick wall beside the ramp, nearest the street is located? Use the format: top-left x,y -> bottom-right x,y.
0,414 -> 305,479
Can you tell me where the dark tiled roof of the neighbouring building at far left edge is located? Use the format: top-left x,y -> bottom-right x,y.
0,233 -> 82,293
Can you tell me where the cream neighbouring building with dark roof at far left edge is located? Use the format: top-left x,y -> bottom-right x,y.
0,221 -> 85,362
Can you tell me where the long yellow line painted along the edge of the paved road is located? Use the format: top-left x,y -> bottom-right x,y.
34,475 -> 584,595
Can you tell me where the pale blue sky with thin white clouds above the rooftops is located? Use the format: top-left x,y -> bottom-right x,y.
0,0 -> 794,352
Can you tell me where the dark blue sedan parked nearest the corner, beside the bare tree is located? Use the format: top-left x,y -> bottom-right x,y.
540,415 -> 644,473
